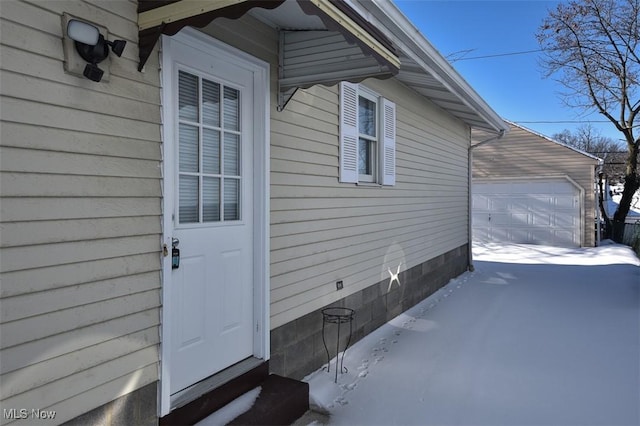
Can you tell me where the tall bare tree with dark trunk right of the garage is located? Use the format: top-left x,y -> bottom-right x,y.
536,0 -> 640,242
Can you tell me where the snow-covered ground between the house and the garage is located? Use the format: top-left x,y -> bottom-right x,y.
305,245 -> 640,426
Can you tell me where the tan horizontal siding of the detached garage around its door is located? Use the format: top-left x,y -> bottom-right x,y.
473,125 -> 598,247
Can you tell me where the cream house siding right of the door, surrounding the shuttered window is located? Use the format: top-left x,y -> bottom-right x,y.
271,75 -> 469,328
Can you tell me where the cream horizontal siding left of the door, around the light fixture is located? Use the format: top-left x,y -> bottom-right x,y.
0,1 -> 161,424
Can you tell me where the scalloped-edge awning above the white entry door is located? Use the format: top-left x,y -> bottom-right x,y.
138,0 -> 400,85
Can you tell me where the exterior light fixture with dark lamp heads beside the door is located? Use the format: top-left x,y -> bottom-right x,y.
67,19 -> 127,82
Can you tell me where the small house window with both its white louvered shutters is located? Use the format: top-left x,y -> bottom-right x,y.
340,82 -> 396,185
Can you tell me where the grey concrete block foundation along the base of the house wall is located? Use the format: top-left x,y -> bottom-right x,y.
269,244 -> 469,379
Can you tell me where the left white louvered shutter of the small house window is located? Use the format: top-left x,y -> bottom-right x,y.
340,82 -> 358,183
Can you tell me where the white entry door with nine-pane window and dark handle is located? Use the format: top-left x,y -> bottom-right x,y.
163,30 -> 266,394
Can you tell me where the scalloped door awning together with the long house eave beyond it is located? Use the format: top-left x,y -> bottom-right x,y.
138,0 -> 509,134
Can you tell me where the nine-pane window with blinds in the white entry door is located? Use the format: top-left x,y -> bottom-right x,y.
177,71 -> 242,224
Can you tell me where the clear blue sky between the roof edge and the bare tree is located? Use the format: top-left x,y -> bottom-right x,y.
394,0 -> 621,146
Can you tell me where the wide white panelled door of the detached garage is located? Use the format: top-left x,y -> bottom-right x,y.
472,179 -> 582,246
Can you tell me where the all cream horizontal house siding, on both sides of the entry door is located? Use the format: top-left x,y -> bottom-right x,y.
0,6 -> 476,422
